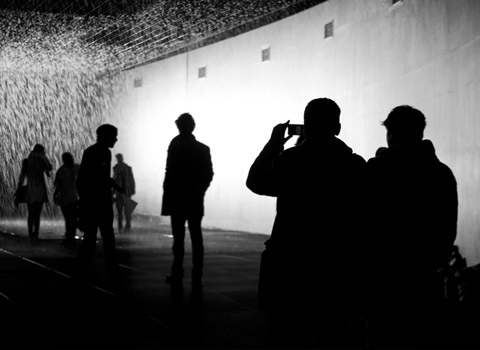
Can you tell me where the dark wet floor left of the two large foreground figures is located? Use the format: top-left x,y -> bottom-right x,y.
0,220 -> 267,349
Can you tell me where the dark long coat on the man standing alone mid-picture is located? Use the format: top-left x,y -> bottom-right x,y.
162,134 -> 213,217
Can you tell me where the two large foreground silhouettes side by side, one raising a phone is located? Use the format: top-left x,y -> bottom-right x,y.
247,98 -> 458,348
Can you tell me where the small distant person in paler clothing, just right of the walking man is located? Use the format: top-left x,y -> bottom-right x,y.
113,153 -> 135,232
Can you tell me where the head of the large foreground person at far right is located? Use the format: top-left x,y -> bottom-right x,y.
382,105 -> 427,147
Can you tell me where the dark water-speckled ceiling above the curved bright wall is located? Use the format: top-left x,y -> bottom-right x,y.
0,0 -> 325,70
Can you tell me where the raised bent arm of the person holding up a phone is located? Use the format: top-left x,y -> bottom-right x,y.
247,121 -> 291,197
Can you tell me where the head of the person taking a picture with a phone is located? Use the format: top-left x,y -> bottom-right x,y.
303,97 -> 341,139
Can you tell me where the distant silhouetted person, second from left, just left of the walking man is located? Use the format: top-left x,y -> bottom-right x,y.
53,152 -> 79,245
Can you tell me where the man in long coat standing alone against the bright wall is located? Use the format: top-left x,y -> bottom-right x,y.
162,113 -> 213,285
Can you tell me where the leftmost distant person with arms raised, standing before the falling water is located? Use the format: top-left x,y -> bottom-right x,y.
18,144 -> 52,242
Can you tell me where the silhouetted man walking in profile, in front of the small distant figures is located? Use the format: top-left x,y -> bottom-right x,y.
77,124 -> 123,278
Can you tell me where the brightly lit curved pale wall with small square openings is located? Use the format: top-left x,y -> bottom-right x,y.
117,0 -> 480,264
